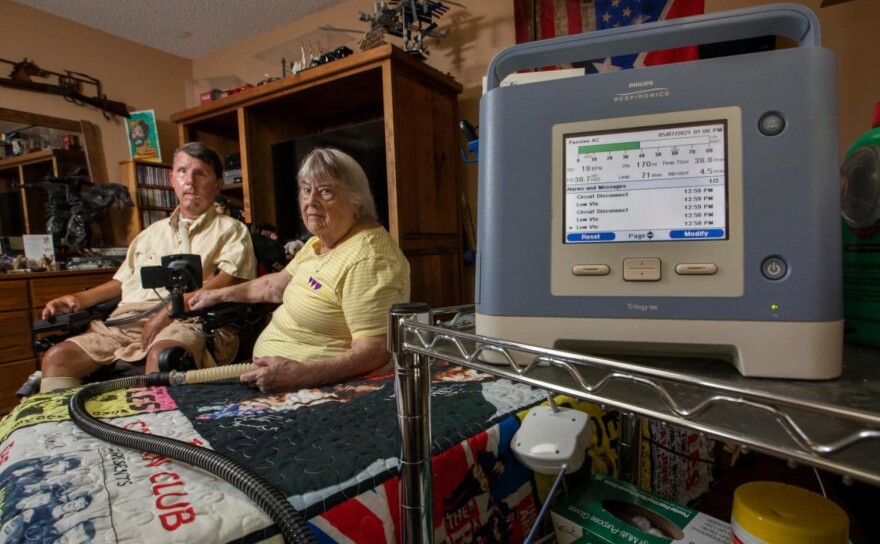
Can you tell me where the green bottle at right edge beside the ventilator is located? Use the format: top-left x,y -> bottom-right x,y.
840,102 -> 880,346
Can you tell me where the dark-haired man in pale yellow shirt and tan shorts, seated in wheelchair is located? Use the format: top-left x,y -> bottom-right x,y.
40,143 -> 256,392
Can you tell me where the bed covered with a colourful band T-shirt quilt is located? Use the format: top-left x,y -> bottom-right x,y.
0,361 -> 545,543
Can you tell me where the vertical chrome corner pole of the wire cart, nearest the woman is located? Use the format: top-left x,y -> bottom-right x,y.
388,303 -> 434,544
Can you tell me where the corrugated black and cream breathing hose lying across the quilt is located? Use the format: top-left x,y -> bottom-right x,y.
68,364 -> 318,544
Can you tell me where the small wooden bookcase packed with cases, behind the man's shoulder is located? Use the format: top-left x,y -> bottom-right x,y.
119,160 -> 177,238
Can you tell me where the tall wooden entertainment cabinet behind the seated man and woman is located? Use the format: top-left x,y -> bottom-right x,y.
171,45 -> 463,307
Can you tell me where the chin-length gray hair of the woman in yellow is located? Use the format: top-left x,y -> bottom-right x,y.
297,147 -> 379,221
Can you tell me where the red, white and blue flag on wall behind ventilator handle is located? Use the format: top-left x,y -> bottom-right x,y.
514,0 -> 704,73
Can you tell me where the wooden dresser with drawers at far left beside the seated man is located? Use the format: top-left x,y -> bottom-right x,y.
0,269 -> 113,415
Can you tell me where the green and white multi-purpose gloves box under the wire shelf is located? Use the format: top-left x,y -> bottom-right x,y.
551,474 -> 730,544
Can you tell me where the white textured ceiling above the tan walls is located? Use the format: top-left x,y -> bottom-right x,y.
11,0 -> 357,59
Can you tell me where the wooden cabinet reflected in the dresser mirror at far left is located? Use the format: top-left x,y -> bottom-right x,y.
0,149 -> 87,236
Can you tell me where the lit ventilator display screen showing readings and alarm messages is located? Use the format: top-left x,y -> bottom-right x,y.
563,120 -> 728,244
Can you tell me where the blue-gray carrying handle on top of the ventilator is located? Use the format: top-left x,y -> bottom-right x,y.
486,3 -> 820,92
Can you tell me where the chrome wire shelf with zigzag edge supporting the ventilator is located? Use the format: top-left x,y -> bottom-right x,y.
403,306 -> 880,485
